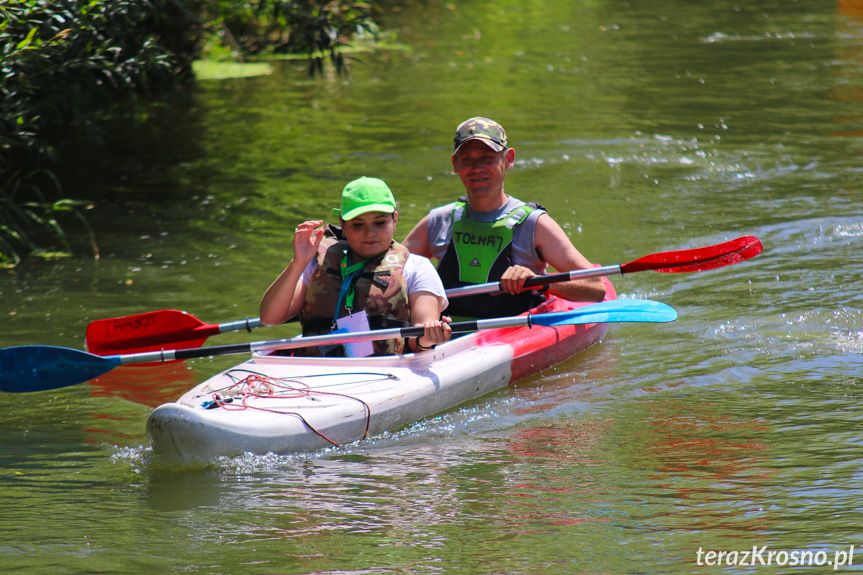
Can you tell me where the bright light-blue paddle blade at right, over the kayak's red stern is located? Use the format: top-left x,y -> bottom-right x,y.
530,299 -> 677,326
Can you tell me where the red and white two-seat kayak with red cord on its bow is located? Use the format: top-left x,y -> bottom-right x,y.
147,278 -> 616,462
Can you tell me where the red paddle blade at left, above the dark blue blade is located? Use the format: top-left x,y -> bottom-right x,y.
87,309 -> 219,355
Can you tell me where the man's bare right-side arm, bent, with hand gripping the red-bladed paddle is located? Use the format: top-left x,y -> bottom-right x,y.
501,214 -> 605,301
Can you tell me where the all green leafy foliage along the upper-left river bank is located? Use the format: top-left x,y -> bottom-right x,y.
0,0 -> 377,264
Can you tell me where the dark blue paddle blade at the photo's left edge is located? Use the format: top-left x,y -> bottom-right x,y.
0,345 -> 120,393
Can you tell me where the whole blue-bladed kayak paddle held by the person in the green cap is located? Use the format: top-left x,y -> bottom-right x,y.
0,299 -> 677,393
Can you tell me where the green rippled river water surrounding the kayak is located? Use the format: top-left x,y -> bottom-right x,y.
0,0 -> 863,575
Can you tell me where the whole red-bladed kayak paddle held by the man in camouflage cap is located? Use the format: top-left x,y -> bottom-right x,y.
81,236 -> 762,355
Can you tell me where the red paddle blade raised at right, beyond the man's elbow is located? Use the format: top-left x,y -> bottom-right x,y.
620,236 -> 764,274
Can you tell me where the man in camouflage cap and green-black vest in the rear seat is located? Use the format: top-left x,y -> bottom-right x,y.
404,118 -> 605,317
